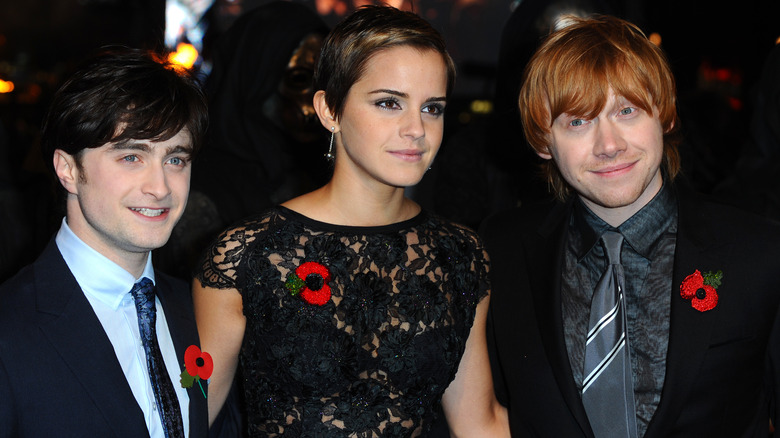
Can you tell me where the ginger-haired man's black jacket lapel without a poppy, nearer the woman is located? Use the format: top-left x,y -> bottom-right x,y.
524,200 -> 593,437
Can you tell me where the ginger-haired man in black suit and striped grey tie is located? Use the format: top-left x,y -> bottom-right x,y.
482,16 -> 780,438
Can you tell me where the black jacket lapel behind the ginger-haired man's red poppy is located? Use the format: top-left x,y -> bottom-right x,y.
645,186 -> 724,438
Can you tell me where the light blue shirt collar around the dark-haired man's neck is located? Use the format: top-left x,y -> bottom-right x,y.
55,218 -> 155,309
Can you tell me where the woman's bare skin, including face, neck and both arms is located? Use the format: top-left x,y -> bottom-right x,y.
193,46 -> 509,437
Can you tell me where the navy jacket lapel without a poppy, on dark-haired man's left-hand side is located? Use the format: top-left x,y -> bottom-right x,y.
34,240 -> 148,436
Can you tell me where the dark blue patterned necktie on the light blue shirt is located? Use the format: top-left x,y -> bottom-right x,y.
130,277 -> 184,438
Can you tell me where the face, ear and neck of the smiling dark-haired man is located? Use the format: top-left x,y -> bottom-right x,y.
52,129 -> 192,278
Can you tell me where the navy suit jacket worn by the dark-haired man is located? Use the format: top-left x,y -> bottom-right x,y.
0,239 -> 208,438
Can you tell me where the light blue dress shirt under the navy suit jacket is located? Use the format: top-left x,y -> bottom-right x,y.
55,218 -> 190,438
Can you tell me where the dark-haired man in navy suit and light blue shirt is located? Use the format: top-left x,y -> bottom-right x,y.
0,49 -> 208,438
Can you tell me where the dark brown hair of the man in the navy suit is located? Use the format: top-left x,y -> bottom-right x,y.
41,47 -> 208,171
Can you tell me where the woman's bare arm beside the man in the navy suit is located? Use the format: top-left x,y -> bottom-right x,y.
192,278 -> 246,426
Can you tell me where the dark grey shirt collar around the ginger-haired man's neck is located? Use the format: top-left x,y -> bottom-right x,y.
572,183 -> 677,260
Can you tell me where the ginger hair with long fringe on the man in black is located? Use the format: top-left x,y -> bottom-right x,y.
518,15 -> 680,200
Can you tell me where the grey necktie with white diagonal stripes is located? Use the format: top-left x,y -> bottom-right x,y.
582,231 -> 637,438
